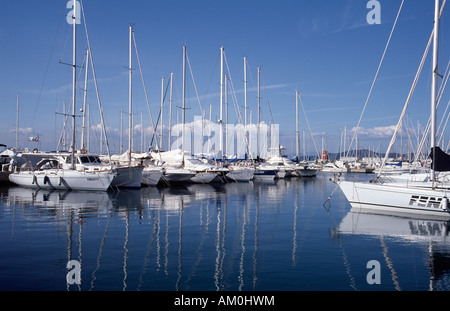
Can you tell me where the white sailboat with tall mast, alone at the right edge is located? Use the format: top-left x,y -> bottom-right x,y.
337,0 -> 450,219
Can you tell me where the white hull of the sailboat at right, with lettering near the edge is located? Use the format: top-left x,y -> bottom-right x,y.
338,181 -> 450,218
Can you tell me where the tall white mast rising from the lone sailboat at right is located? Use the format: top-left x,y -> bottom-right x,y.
431,0 -> 439,182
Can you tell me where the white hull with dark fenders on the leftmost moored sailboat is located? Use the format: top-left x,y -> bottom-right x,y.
9,169 -> 115,191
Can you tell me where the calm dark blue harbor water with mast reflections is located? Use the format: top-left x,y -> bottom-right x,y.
0,173 -> 450,291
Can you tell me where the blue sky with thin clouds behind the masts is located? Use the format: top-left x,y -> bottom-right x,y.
0,0 -> 450,153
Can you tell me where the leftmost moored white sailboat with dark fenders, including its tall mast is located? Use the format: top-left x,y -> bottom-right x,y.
9,5 -> 117,191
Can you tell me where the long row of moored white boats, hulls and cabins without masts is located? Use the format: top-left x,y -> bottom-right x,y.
2,149 -> 319,191
